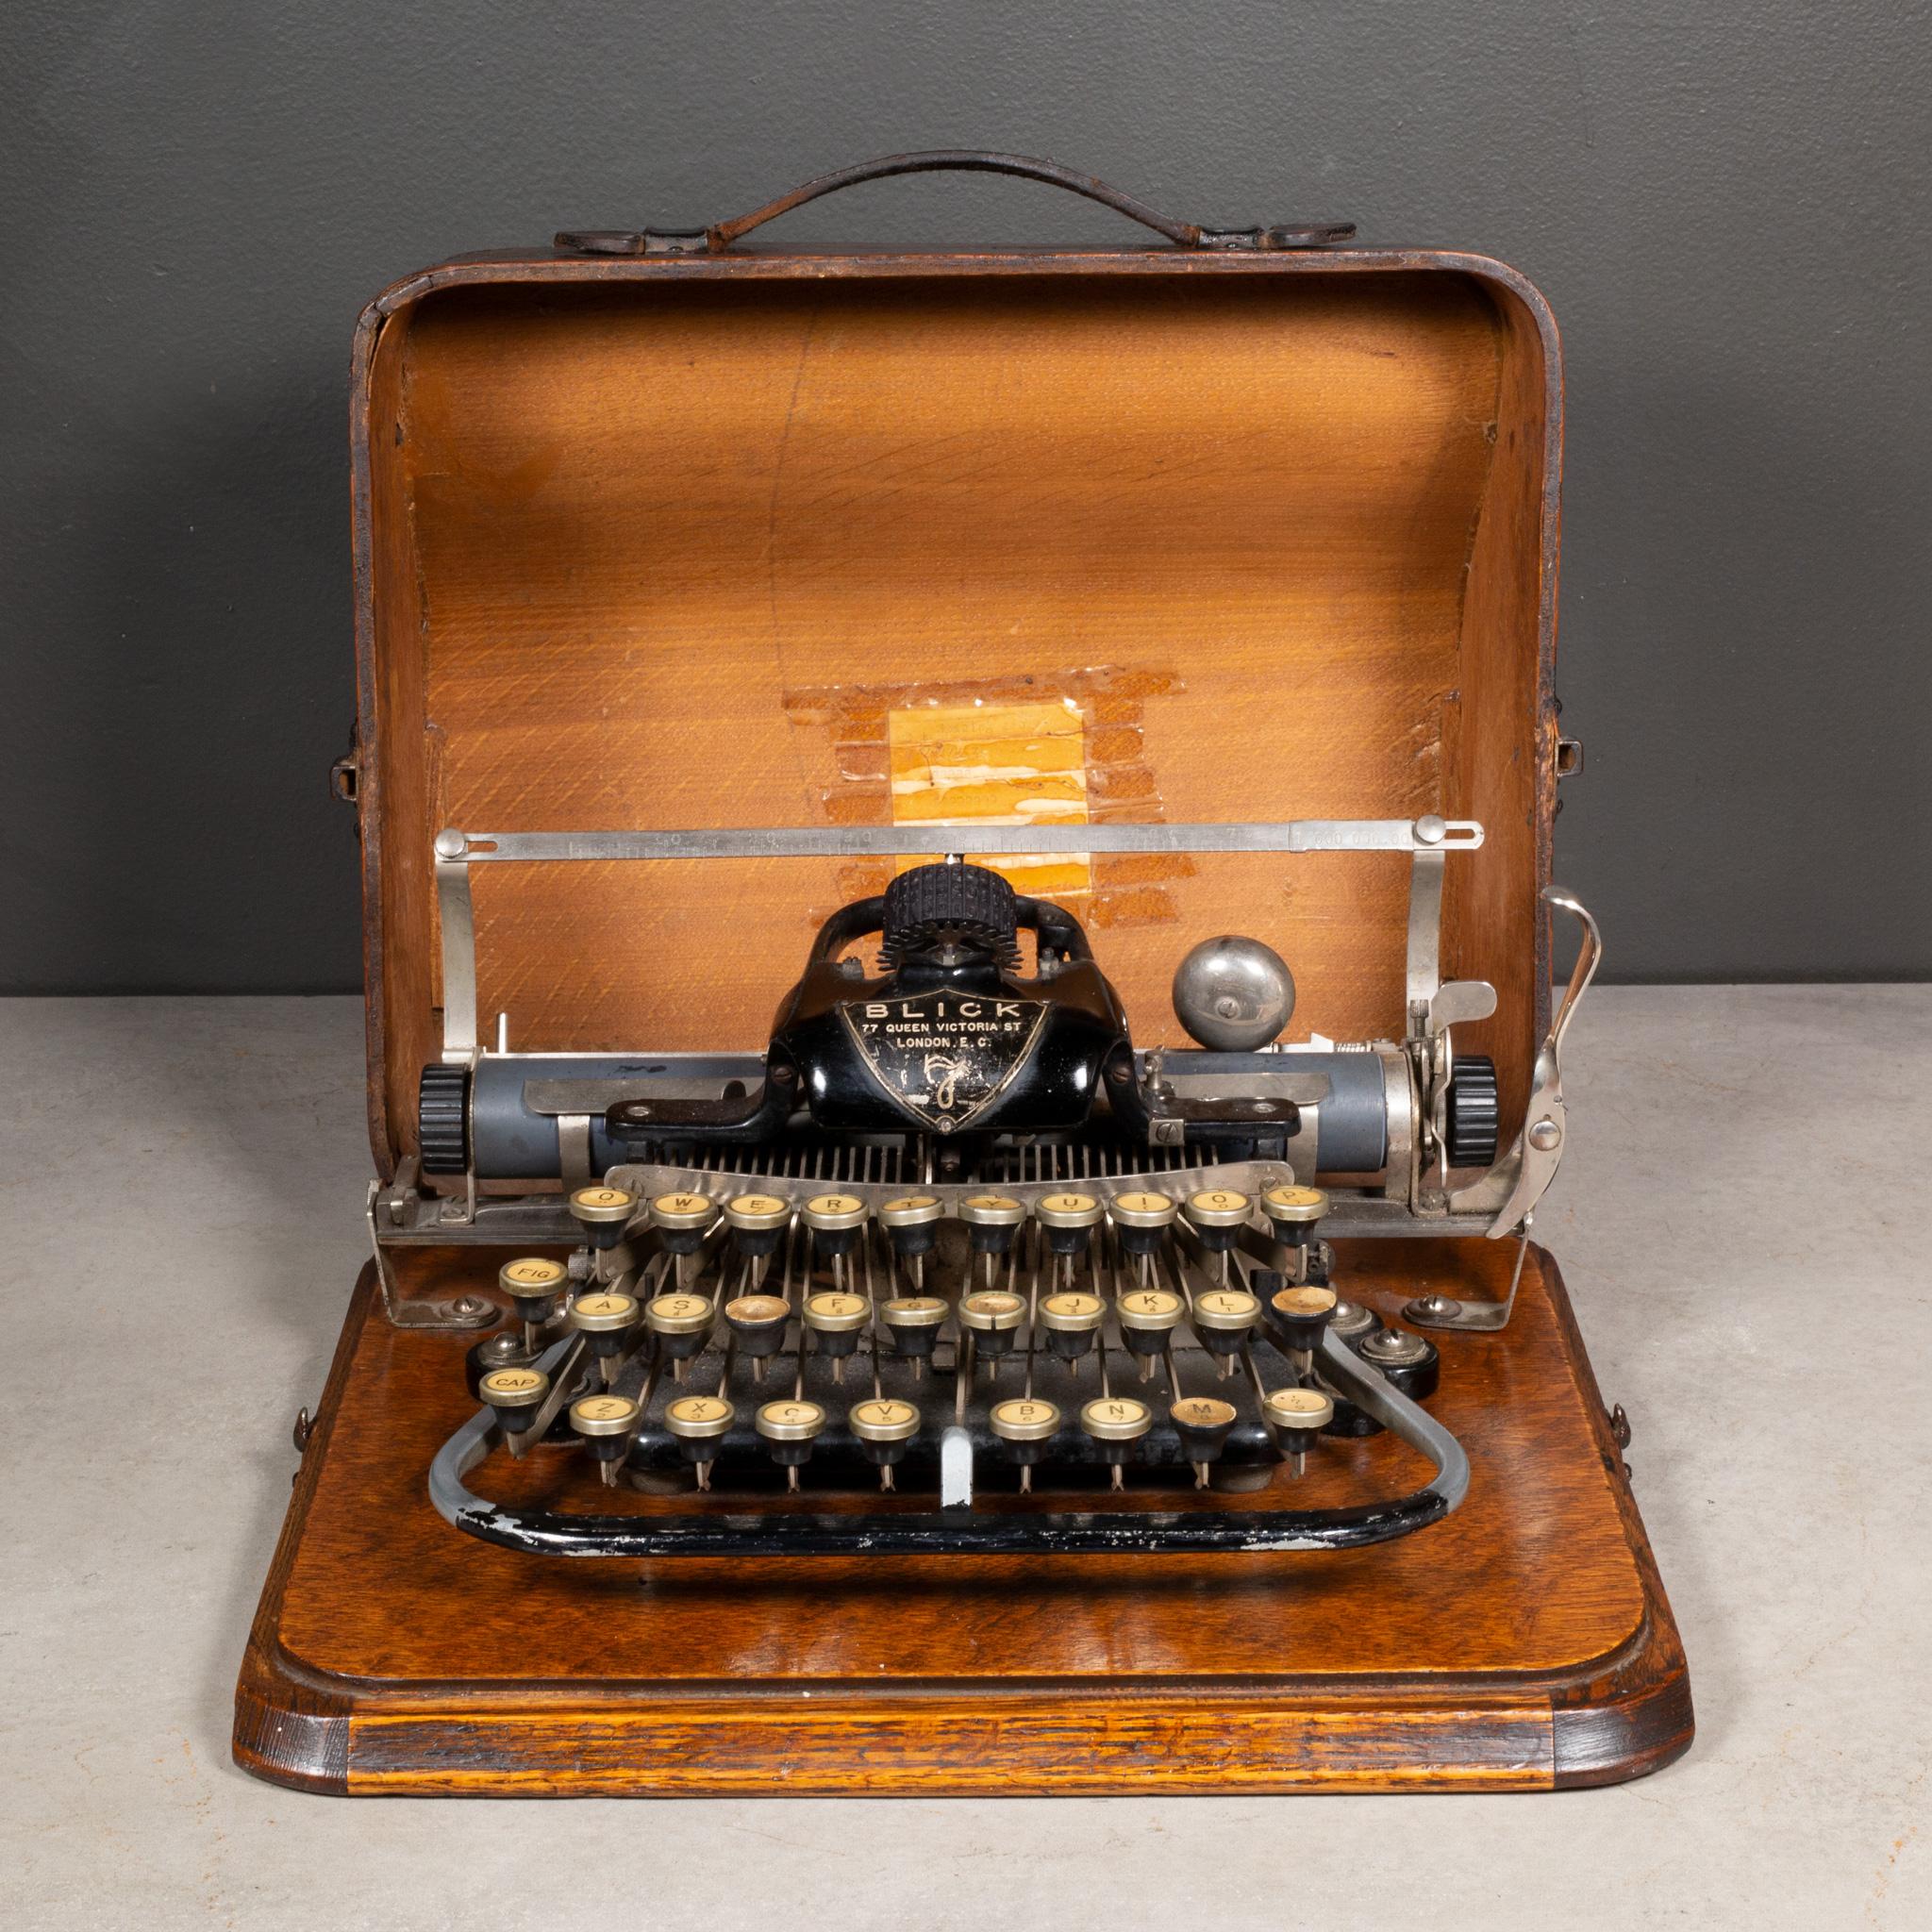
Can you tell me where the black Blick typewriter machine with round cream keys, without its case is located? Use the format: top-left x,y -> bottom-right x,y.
380,815 -> 1598,1557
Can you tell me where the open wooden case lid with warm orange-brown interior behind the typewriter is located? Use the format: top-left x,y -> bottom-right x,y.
358,257 -> 1559,1171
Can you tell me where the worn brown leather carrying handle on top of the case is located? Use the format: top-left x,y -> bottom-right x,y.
557,147 -> 1355,255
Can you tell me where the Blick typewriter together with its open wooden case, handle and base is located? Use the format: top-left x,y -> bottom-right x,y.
234,151 -> 1690,1795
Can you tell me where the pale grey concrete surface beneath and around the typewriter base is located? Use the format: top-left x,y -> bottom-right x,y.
0,985 -> 1932,1932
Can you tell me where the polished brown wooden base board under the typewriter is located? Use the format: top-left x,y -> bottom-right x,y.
234,1242 -> 1692,1797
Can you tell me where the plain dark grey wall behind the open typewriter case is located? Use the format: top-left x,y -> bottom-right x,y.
0,0 -> 1932,991
